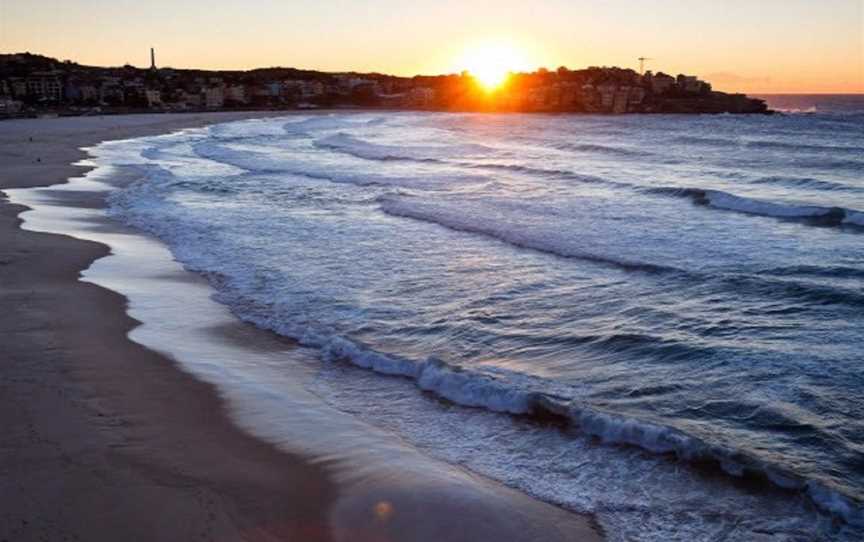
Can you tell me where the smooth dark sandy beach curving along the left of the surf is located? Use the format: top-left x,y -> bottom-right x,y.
0,113 -> 600,541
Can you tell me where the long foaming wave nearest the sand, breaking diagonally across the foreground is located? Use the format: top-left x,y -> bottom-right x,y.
238,313 -> 864,526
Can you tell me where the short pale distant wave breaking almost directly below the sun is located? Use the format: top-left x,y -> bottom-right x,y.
315,132 -> 493,163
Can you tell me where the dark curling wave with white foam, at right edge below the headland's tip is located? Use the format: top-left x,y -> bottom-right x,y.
645,187 -> 864,230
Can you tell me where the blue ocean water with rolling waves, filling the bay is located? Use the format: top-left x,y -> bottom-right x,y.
101,99 -> 864,540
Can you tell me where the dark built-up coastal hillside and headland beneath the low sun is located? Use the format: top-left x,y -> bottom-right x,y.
0,53 -> 770,117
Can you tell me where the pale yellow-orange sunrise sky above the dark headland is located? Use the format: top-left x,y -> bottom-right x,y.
0,0 -> 864,93
